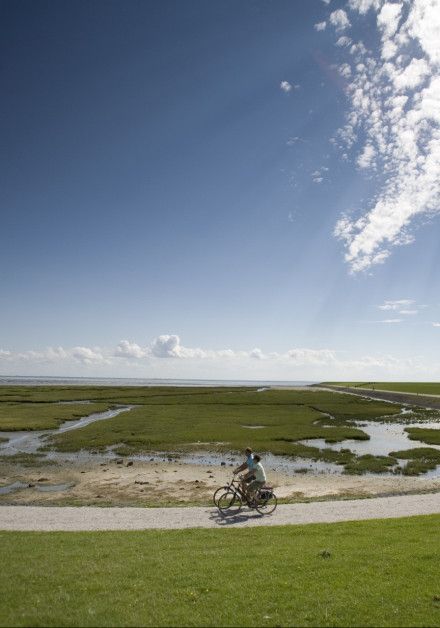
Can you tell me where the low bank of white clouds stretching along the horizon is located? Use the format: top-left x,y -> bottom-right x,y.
0,334 -> 434,380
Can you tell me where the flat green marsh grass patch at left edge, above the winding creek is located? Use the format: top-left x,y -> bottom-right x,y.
0,402 -> 115,432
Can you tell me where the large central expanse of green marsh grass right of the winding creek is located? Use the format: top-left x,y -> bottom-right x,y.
43,389 -> 399,464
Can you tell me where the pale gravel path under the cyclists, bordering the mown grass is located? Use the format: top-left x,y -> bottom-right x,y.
0,493 -> 440,531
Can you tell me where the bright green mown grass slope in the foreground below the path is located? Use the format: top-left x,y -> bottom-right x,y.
0,516 -> 440,626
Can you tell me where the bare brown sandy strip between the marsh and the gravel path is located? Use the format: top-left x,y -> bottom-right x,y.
0,459 -> 440,506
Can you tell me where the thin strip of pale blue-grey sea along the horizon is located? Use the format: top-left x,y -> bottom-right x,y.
0,375 -> 318,388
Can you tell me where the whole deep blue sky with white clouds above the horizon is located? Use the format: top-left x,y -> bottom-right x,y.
0,0 -> 440,381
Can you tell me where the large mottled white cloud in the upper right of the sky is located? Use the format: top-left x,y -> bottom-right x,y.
334,0 -> 440,273
